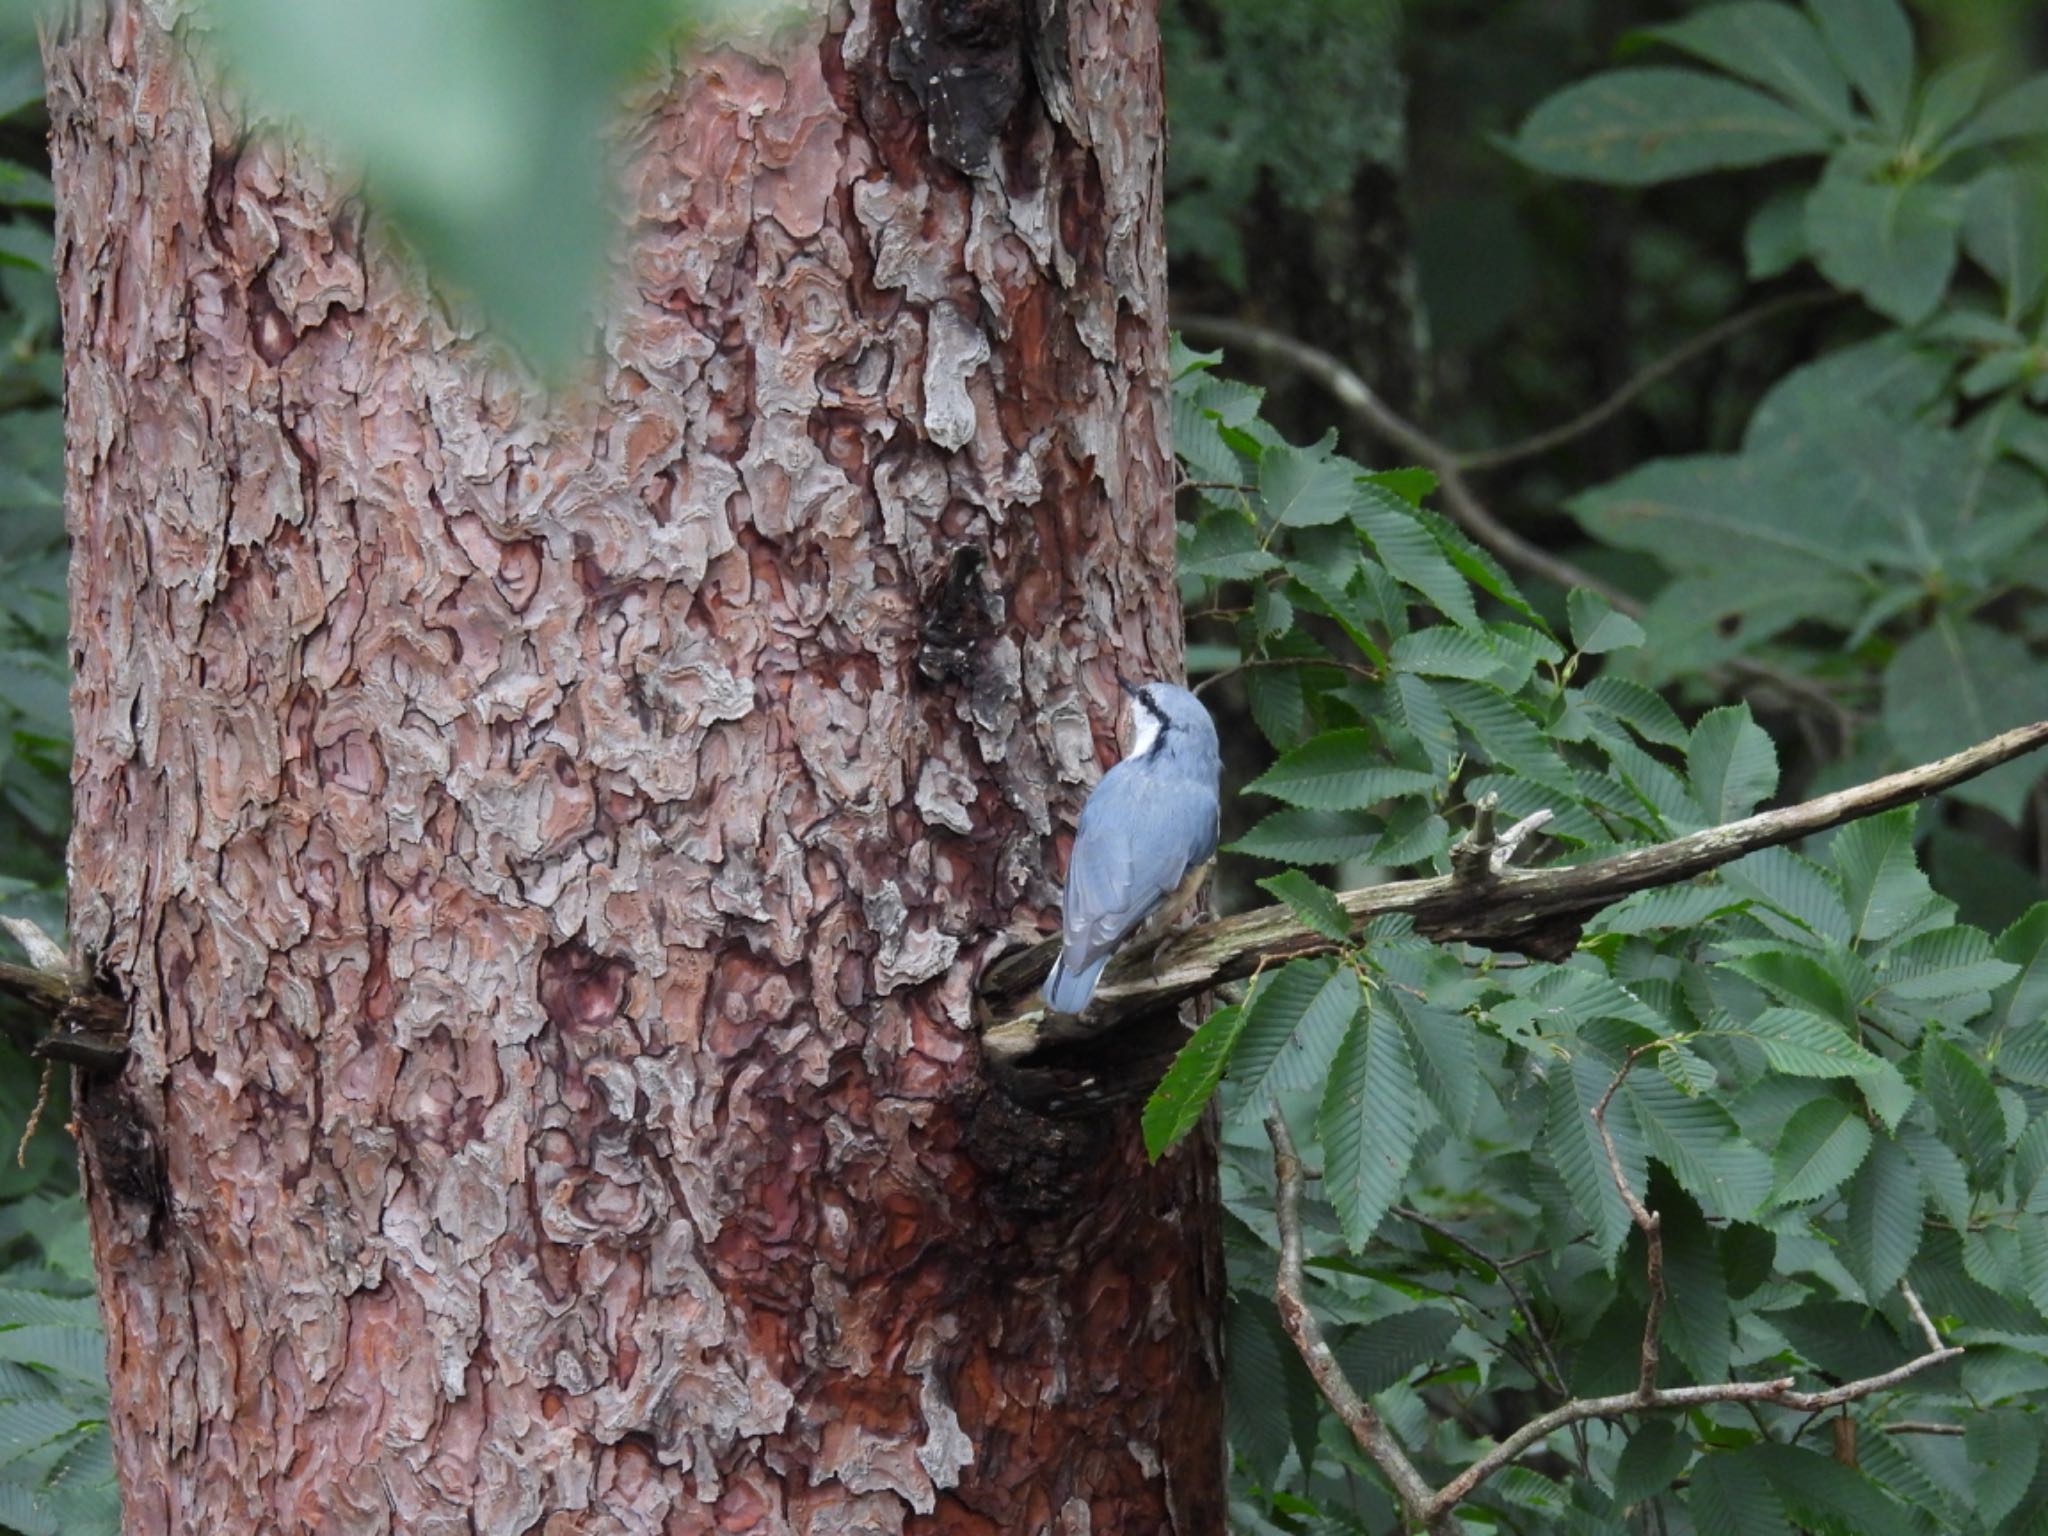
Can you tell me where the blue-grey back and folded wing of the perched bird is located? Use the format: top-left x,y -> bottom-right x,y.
1061,764 -> 1217,963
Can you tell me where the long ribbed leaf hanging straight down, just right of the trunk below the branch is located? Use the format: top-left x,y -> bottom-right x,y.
1317,1010 -> 1421,1251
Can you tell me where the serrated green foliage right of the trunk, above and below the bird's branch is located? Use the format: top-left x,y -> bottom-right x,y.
1171,342 -> 2048,1536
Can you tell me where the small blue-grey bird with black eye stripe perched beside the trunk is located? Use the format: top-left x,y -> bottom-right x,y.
1040,682 -> 1223,1014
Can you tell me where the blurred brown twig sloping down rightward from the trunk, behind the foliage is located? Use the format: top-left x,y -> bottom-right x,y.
1182,315 -> 1849,741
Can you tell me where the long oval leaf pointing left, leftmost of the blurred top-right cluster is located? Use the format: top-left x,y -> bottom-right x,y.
1511,68 -> 1829,186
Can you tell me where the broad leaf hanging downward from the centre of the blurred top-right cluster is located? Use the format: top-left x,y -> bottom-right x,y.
1806,152 -> 1964,326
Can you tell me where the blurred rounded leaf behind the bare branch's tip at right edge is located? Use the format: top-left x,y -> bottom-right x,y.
1884,610 -> 2048,825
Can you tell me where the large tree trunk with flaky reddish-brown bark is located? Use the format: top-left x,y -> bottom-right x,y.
49,0 -> 1223,1536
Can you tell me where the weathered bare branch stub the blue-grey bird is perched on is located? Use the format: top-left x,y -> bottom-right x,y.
981,721 -> 2048,1061
